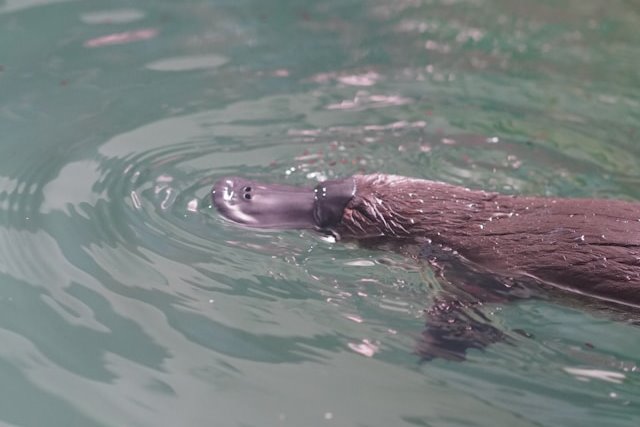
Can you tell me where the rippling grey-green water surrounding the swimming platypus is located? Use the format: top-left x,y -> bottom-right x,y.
0,0 -> 640,426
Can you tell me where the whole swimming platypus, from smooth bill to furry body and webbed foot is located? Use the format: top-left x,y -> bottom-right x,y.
212,174 -> 640,359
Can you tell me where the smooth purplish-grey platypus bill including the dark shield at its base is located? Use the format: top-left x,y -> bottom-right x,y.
211,177 -> 356,231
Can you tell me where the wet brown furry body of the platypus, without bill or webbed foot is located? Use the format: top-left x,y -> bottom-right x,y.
335,174 -> 640,306
